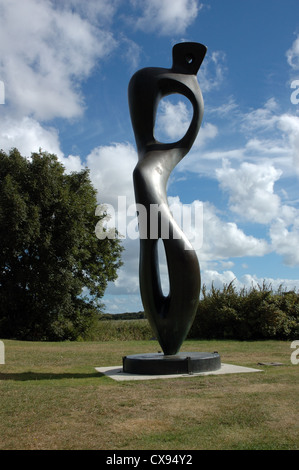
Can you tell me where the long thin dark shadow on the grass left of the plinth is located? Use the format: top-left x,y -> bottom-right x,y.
0,371 -> 104,382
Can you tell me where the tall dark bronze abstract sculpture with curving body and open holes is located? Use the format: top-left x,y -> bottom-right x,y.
124,42 -> 221,372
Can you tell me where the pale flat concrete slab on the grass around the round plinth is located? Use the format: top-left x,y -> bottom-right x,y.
95,364 -> 263,381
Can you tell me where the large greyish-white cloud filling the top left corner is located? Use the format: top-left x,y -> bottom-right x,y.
0,0 -> 116,120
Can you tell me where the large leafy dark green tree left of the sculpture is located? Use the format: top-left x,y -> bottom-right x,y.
0,149 -> 122,340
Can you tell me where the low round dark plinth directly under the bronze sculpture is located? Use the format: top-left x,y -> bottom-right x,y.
123,352 -> 221,375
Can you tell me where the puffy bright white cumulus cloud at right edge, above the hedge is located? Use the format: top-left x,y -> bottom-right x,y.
217,159 -> 299,266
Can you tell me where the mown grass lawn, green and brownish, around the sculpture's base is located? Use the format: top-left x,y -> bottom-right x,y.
0,340 -> 299,450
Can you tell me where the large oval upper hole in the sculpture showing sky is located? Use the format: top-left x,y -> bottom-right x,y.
154,94 -> 193,143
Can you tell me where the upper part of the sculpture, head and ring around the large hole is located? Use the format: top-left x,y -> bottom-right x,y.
128,42 -> 207,159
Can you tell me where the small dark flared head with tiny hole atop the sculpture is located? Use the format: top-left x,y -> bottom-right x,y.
172,42 -> 207,75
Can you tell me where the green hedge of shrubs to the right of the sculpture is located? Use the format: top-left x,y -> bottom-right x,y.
188,282 -> 299,340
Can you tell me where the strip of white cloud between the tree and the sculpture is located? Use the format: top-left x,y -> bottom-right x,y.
86,143 -> 140,304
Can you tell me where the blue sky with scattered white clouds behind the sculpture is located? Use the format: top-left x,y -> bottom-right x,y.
0,0 -> 299,313
